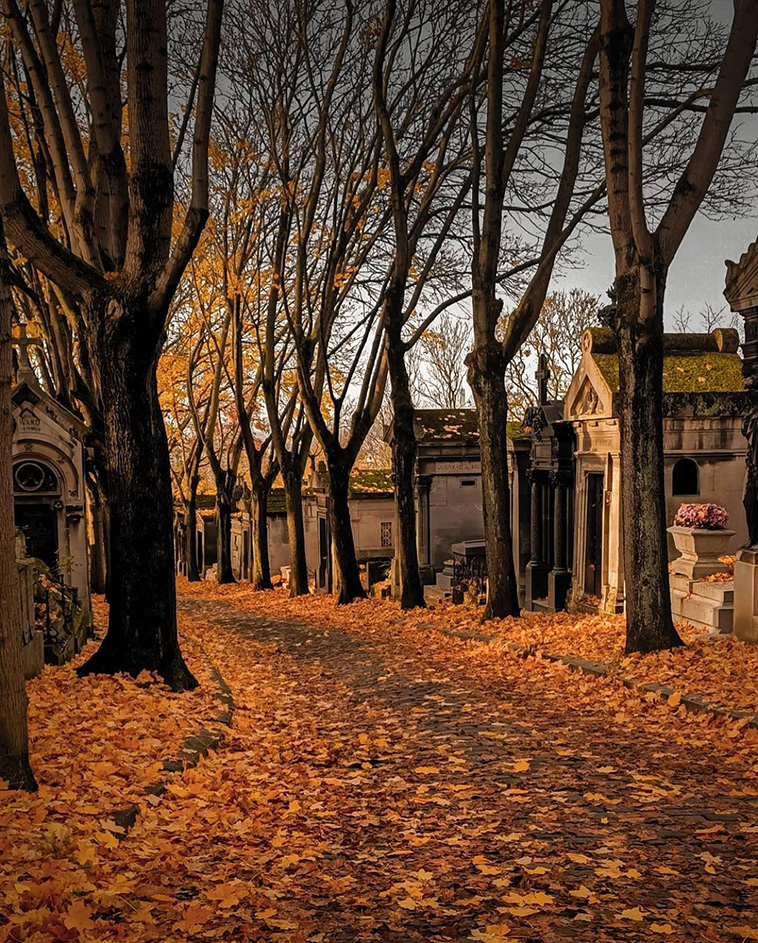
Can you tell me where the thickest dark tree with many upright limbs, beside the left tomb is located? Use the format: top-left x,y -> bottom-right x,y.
0,0 -> 222,690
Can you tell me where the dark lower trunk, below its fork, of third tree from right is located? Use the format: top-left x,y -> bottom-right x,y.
388,336 -> 426,609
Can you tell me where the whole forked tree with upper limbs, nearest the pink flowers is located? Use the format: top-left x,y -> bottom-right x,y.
599,0 -> 758,652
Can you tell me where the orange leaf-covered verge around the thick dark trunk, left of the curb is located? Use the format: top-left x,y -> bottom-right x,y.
0,599 -> 219,941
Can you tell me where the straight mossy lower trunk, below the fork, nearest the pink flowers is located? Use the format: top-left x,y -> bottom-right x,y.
615,273 -> 682,652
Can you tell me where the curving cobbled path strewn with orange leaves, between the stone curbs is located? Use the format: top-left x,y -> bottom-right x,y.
172,598 -> 758,943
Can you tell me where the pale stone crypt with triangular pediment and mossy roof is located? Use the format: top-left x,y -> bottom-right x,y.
564,328 -> 747,612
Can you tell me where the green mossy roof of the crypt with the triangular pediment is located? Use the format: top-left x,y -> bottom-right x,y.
592,351 -> 745,393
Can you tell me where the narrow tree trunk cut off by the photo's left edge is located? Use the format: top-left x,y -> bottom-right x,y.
0,242 -> 37,791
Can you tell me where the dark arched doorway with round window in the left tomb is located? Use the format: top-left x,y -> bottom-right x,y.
13,459 -> 62,569
